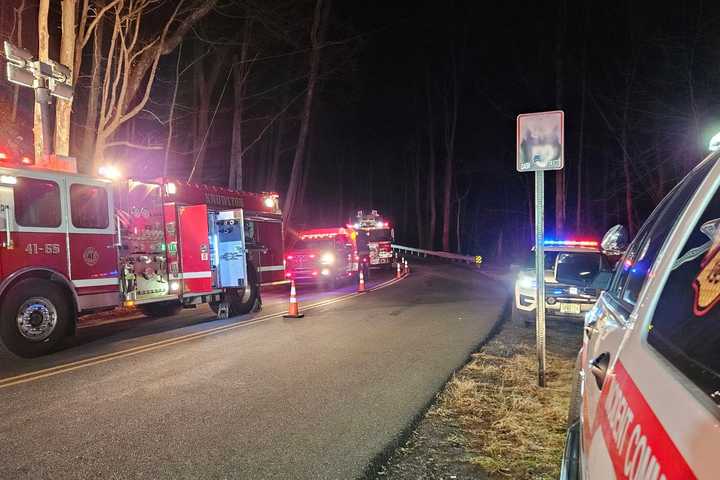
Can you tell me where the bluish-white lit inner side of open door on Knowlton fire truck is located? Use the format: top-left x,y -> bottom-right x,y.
215,210 -> 247,288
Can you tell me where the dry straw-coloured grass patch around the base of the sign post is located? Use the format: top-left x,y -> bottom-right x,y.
429,324 -> 577,479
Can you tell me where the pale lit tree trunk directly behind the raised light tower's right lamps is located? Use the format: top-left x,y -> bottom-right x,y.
55,0 -> 77,155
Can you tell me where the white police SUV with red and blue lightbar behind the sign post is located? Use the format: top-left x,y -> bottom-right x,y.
512,240 -> 609,324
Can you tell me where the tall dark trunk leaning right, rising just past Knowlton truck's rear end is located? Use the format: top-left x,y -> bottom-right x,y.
283,0 -> 330,229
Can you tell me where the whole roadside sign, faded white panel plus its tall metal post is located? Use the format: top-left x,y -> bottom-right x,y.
517,111 -> 565,387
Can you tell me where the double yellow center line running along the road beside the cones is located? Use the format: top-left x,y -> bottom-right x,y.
0,276 -> 405,389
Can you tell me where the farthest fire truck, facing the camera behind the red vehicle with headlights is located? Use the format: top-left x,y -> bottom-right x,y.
348,210 -> 395,267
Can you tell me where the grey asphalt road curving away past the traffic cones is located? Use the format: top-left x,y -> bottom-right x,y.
0,265 -> 506,480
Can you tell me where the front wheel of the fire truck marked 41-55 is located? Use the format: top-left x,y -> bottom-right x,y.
0,278 -> 74,358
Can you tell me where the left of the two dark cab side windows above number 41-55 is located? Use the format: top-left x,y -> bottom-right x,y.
13,177 -> 62,228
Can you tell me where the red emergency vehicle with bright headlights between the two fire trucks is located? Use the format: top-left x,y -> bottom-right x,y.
285,228 -> 359,288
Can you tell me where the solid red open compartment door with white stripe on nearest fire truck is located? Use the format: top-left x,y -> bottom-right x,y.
178,205 -> 212,294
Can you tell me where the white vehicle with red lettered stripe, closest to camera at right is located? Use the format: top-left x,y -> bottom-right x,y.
557,152 -> 720,480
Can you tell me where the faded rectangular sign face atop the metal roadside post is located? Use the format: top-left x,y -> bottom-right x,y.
517,110 -> 565,172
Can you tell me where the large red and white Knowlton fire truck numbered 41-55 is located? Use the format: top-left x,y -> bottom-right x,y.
0,157 -> 285,357
